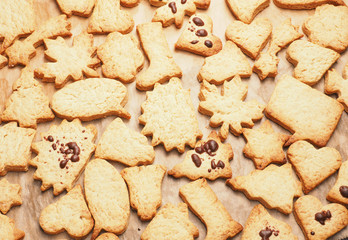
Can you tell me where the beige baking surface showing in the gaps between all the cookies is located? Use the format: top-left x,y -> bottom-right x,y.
0,0 -> 348,240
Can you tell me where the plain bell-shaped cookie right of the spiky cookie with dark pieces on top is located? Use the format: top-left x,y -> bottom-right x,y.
95,118 -> 155,167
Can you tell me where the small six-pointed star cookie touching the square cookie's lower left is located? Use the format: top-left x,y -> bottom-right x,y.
243,120 -> 290,169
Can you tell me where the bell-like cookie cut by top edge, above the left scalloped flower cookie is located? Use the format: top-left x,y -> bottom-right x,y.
87,0 -> 134,34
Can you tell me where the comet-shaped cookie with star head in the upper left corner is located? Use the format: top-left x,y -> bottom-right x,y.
6,15 -> 71,67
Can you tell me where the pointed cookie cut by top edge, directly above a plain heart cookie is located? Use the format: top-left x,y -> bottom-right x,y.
226,0 -> 270,24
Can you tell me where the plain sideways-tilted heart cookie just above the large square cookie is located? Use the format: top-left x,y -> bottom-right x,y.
286,40 -> 340,86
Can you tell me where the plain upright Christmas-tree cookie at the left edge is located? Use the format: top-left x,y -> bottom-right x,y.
1,68 -> 54,128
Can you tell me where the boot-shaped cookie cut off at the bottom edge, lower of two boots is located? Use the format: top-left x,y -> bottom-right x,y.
179,178 -> 243,240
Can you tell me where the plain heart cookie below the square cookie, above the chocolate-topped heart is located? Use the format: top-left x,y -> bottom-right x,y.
287,141 -> 342,194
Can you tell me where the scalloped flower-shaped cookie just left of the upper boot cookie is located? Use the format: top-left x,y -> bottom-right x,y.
97,32 -> 145,83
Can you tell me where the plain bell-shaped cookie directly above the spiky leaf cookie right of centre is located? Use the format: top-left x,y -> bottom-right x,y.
197,41 -> 252,84
